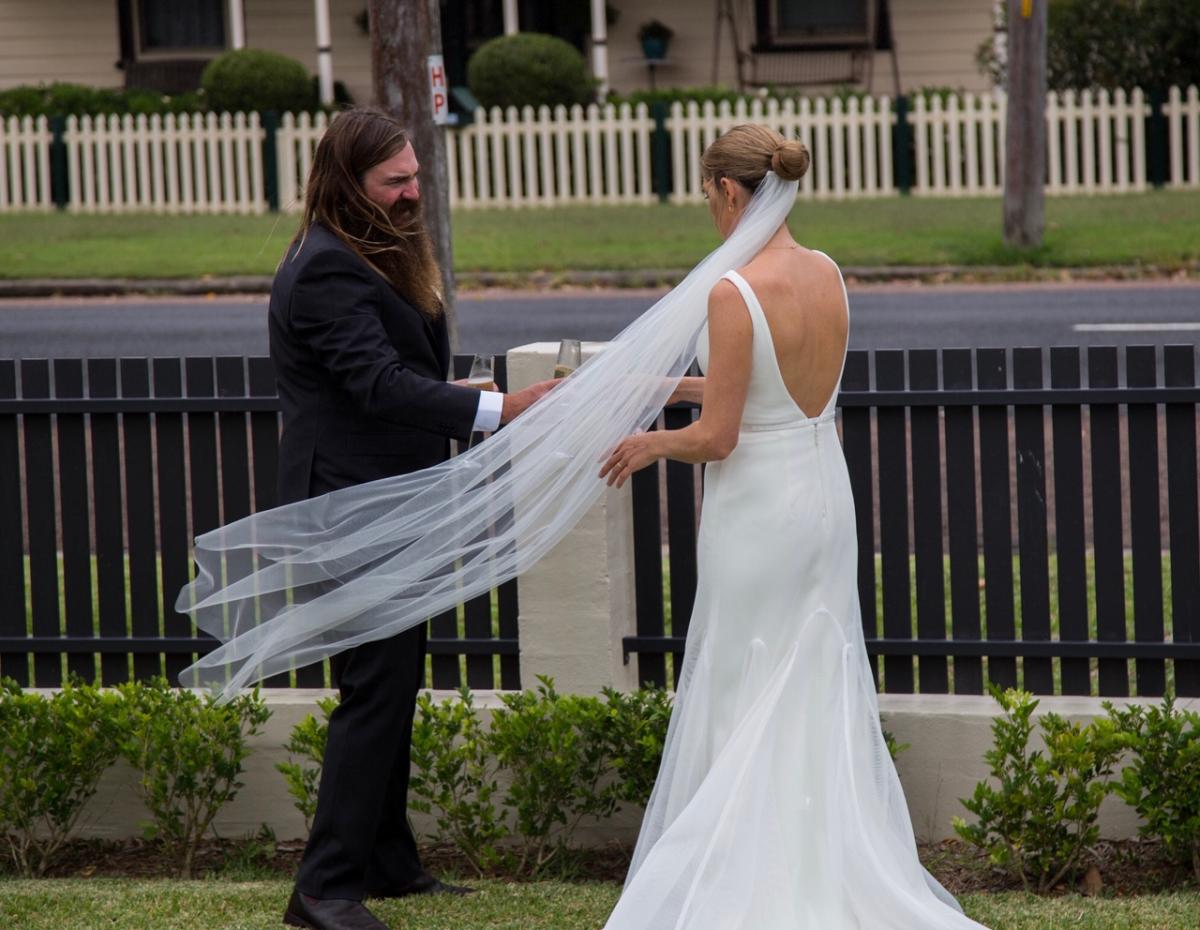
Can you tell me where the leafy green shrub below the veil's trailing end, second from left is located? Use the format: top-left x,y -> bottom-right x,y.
118,678 -> 271,878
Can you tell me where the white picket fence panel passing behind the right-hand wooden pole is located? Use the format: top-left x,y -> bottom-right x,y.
910,88 -> 1150,197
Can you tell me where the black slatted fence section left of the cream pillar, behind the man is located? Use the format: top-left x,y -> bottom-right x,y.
0,356 -> 521,689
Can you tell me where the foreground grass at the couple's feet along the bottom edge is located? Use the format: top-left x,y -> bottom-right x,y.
0,878 -> 1200,930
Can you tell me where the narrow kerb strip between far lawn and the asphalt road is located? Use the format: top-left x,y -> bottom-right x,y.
0,265 -> 1200,298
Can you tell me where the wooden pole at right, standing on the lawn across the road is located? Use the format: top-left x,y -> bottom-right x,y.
1004,0 -> 1048,248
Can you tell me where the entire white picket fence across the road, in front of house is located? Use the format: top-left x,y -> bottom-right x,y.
0,86 -> 1200,214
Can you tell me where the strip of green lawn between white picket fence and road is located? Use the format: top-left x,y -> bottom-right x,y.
0,191 -> 1200,278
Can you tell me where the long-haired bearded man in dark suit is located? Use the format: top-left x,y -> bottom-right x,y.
269,109 -> 553,930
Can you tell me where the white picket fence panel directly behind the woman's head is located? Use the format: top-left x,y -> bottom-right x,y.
667,97 -> 896,203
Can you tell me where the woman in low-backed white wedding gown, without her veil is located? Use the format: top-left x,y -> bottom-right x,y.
600,125 -> 980,930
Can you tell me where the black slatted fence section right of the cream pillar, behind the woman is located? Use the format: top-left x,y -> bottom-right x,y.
624,346 -> 1200,696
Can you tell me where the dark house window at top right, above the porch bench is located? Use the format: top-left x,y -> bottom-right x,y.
756,0 -> 877,49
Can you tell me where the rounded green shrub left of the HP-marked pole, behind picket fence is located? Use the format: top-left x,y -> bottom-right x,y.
200,48 -> 317,113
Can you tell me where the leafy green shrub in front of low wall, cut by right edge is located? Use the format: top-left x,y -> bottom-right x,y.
1105,696 -> 1200,882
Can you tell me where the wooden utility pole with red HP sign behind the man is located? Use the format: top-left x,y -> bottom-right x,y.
367,0 -> 458,348
